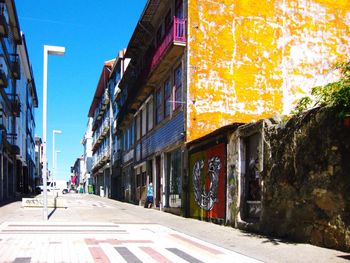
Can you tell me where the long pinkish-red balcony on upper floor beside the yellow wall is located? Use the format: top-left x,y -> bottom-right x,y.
148,17 -> 186,83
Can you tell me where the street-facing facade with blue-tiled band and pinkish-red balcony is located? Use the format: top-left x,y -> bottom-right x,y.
117,1 -> 187,213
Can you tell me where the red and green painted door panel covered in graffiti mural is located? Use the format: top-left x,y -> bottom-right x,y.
189,143 -> 226,220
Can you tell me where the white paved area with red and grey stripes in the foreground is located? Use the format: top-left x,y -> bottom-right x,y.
0,222 -> 259,263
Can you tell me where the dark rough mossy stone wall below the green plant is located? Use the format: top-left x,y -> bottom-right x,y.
259,109 -> 350,251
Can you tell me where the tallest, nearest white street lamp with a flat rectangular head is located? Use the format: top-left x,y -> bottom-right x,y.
42,45 -> 65,220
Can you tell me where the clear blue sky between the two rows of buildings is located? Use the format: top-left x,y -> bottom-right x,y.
15,0 -> 147,180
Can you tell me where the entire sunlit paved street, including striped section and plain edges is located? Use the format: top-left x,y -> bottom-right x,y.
0,194 -> 349,263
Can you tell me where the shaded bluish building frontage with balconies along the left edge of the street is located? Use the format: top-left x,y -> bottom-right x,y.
0,0 -> 38,201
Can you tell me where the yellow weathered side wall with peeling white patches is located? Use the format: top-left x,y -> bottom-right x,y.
187,0 -> 350,141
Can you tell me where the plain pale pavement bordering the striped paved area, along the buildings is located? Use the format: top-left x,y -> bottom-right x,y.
0,194 -> 350,262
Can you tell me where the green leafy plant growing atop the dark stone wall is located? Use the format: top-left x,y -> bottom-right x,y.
293,62 -> 350,119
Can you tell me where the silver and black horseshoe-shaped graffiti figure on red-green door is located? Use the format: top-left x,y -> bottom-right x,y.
192,156 -> 221,211
